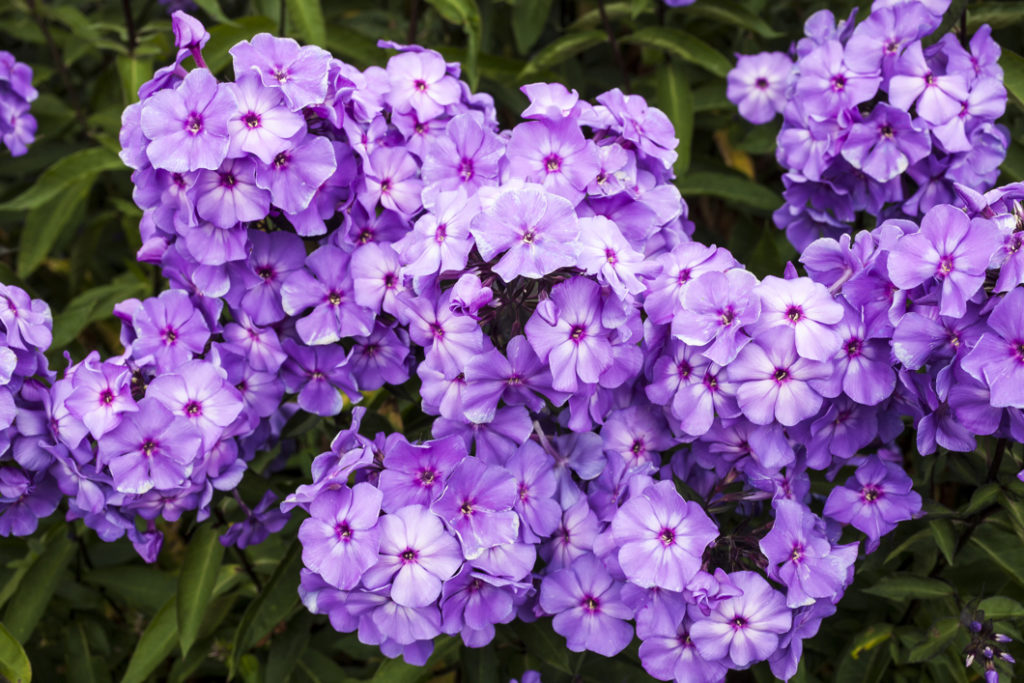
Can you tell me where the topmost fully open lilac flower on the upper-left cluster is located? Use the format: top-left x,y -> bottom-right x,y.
228,33 -> 331,112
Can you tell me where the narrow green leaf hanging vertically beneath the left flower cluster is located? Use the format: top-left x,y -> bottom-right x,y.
177,524 -> 224,655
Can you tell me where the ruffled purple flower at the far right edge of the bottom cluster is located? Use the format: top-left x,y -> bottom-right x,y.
759,499 -> 857,607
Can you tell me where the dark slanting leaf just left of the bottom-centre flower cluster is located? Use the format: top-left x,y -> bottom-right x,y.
228,540 -> 302,675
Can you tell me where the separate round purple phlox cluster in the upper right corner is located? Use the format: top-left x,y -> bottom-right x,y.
727,0 -> 1009,250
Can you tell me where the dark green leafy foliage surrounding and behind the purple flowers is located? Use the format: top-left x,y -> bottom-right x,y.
0,0 -> 1024,683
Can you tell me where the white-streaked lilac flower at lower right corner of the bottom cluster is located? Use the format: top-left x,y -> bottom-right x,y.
690,571 -> 793,669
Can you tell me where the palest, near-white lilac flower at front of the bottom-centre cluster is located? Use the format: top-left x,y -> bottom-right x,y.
362,505 -> 463,607
